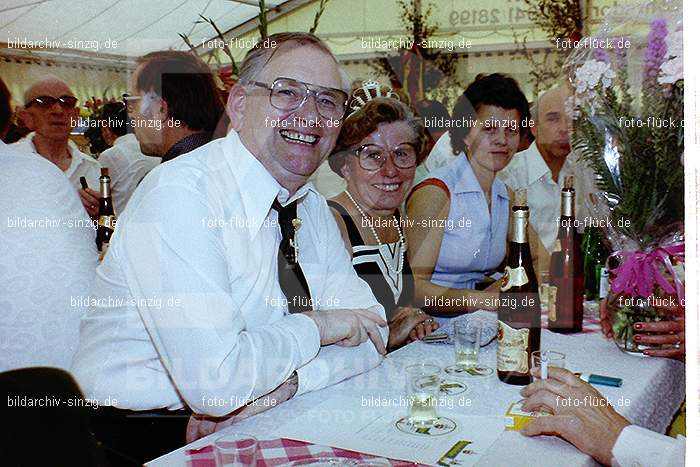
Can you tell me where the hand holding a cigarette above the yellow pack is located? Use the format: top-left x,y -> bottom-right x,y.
520,368 -> 630,465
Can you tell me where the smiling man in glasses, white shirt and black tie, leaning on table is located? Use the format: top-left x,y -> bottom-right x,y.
73,33 -> 387,461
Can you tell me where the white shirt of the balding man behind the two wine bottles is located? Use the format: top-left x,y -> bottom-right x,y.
497,143 -> 593,253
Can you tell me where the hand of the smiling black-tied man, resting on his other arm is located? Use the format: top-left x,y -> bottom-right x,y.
304,310 -> 387,355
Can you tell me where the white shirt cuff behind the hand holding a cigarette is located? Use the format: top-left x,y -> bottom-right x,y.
612,425 -> 685,467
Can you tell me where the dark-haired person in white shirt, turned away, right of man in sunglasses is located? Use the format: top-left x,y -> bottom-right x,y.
99,102 -> 160,216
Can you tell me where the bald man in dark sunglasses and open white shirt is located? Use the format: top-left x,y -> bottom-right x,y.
15,77 -> 100,217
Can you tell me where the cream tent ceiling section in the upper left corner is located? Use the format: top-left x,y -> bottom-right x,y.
0,0 -> 286,58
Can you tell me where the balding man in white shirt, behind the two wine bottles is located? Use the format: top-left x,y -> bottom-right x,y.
498,85 -> 593,253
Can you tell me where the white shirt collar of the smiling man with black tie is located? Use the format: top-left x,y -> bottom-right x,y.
224,131 -> 320,240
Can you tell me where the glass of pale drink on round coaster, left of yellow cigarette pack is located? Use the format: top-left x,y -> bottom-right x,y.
405,363 -> 441,426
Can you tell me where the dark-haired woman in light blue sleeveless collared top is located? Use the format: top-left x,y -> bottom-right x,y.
407,73 -> 541,324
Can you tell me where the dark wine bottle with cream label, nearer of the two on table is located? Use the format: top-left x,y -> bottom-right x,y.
496,190 -> 541,386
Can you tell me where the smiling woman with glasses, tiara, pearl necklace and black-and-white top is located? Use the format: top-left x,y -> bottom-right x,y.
328,97 -> 437,349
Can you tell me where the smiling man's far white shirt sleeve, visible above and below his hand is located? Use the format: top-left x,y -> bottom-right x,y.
296,207 -> 389,395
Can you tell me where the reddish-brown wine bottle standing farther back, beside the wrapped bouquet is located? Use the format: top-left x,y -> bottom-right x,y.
548,176 -> 584,333
